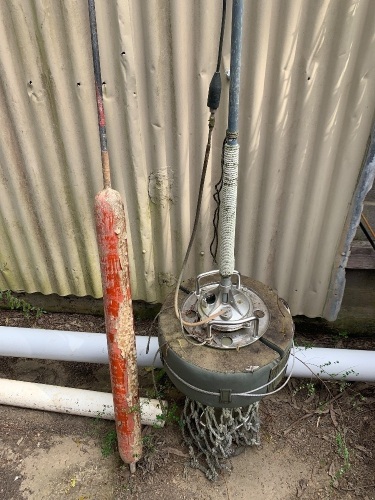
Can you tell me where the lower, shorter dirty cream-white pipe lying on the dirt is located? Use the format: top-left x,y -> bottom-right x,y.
0,378 -> 167,427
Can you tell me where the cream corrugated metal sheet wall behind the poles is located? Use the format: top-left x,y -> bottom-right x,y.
0,0 -> 375,319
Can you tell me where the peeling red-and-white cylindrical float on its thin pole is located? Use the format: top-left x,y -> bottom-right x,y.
88,0 -> 142,472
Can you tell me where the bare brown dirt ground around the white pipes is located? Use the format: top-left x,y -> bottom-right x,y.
0,311 -> 375,500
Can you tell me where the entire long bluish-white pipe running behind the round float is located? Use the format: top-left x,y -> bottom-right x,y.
0,326 -> 375,382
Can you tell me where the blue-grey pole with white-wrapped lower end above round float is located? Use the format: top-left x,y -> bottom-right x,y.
219,0 -> 243,287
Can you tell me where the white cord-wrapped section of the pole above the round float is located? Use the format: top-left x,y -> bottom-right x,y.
219,144 -> 240,276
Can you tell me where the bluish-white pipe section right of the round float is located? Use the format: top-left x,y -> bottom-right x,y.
286,347 -> 375,382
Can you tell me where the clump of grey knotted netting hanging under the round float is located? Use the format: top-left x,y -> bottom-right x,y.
182,398 -> 260,481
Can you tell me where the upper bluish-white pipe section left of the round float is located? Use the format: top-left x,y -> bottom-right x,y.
0,326 -> 162,368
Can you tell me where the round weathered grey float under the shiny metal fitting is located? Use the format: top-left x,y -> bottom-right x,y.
159,275 -> 294,408
